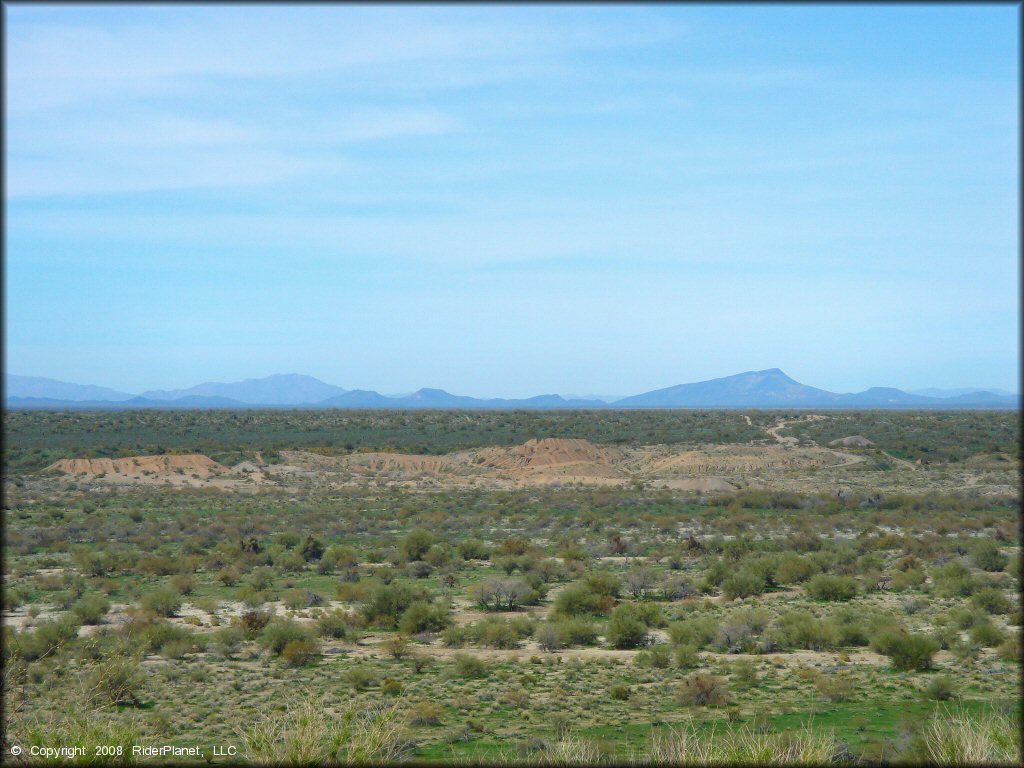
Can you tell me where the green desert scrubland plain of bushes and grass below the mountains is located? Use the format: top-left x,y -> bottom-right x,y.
3,411 -> 1021,764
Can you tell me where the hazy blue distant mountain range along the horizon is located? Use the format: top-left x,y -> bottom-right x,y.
4,368 -> 1020,410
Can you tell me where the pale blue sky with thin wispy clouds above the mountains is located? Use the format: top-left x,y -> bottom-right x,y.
3,4 -> 1020,397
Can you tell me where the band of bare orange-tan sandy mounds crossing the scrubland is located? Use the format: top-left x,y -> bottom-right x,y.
46,430 -> 1017,494
